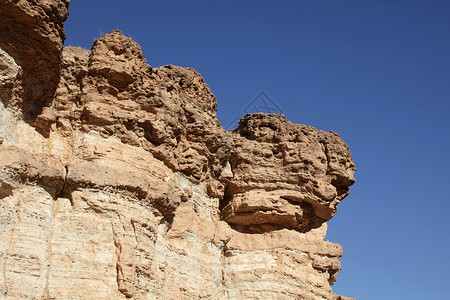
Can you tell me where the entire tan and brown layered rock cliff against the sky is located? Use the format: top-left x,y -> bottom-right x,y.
0,0 -> 355,299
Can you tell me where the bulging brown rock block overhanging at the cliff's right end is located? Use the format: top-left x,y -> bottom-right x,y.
223,114 -> 355,232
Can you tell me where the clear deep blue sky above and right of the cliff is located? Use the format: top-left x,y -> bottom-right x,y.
65,0 -> 450,300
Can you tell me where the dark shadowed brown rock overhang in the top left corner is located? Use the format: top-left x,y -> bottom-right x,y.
0,0 -> 69,121
